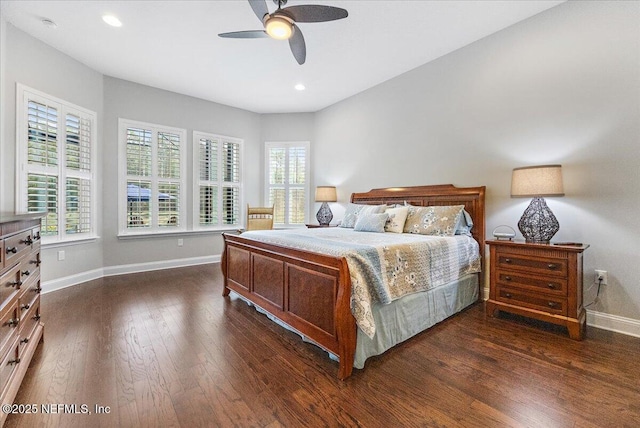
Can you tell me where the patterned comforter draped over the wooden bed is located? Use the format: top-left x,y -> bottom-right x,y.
242,227 -> 480,338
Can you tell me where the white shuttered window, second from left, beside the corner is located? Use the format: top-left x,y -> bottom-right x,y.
118,119 -> 187,235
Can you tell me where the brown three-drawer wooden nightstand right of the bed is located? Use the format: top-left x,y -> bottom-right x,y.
486,240 -> 589,340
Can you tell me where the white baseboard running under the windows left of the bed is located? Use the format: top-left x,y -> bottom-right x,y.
42,255 -> 221,293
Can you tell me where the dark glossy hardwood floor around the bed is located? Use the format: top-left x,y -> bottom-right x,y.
5,264 -> 640,428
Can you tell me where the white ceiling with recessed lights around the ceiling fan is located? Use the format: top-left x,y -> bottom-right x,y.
0,0 -> 564,113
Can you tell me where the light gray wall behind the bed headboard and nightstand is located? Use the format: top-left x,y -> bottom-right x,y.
313,2 -> 640,320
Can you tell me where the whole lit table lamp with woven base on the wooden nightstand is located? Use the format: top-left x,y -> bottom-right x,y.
511,165 -> 564,243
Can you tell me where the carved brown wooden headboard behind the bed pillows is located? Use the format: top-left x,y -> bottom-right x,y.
351,184 -> 486,288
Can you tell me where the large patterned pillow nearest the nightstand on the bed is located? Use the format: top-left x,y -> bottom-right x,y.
404,205 -> 464,236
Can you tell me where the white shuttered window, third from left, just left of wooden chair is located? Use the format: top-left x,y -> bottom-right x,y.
193,132 -> 243,229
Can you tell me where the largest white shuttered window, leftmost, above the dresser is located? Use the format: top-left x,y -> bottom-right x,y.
16,84 -> 97,244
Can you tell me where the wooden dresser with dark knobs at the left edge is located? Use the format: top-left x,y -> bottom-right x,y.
0,213 -> 44,425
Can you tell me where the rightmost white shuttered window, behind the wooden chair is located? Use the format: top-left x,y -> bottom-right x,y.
265,141 -> 309,226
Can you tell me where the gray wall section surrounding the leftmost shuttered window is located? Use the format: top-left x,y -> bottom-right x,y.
0,24 -> 103,281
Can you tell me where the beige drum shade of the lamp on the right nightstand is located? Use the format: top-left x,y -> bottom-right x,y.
511,165 -> 564,197
